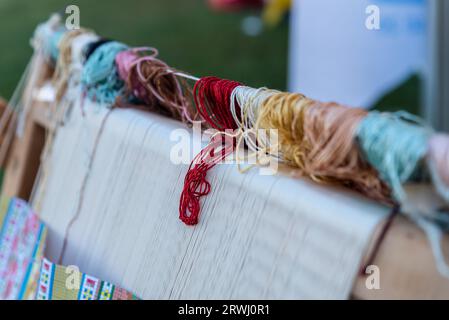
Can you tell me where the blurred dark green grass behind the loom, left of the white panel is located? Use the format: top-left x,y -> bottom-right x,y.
0,0 -> 288,98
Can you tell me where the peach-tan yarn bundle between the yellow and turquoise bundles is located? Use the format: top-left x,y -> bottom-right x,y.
296,101 -> 390,203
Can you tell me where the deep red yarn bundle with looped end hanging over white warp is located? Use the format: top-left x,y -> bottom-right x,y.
179,77 -> 241,226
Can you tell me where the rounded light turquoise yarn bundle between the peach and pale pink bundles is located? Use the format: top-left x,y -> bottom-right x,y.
357,112 -> 432,203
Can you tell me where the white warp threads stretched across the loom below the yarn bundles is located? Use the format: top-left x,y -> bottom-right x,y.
34,94 -> 386,299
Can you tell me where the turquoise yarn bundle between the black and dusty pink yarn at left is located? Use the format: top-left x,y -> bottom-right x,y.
81,41 -> 128,104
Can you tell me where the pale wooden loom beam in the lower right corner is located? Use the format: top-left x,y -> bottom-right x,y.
353,216 -> 449,300
